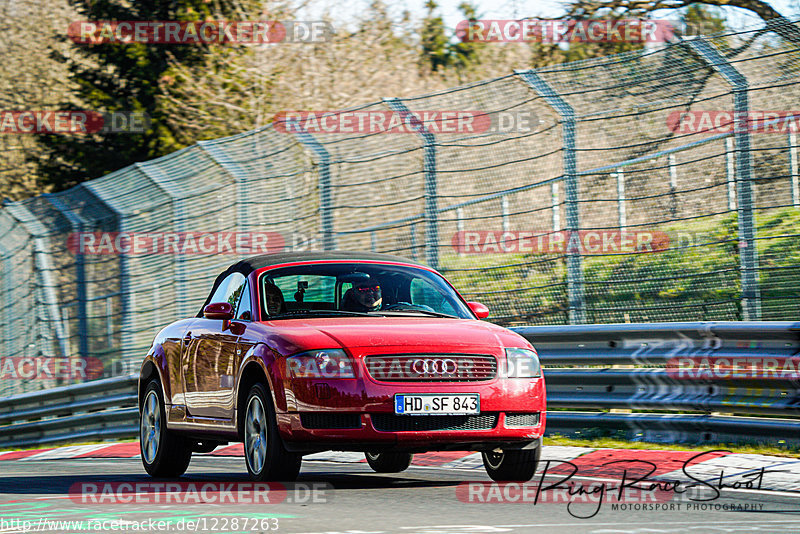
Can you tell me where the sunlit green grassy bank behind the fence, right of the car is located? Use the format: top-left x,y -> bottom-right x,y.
441,208 -> 800,324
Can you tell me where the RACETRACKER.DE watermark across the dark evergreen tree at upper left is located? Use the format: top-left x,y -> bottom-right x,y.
67,20 -> 335,45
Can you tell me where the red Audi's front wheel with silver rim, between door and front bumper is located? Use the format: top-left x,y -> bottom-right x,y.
242,384 -> 303,482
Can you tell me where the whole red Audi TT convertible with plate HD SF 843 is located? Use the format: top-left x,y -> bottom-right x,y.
139,252 -> 545,481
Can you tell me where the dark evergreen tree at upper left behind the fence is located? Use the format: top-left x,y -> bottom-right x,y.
32,0 -> 247,190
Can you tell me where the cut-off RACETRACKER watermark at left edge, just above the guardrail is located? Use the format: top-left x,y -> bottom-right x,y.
0,356 -> 104,381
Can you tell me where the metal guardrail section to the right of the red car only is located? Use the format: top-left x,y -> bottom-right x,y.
512,322 -> 800,445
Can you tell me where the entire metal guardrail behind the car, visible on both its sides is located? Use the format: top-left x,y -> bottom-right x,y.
0,322 -> 800,448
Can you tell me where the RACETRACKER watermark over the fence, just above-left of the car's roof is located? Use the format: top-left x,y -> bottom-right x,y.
67,232 -> 316,256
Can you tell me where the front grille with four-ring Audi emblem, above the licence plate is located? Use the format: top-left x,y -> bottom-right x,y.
364,354 -> 497,382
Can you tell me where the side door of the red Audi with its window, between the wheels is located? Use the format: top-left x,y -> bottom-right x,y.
183,273 -> 249,419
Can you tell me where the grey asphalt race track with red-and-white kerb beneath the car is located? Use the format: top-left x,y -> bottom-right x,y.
0,444 -> 800,534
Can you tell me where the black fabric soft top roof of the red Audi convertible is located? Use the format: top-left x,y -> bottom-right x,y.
197,250 -> 421,317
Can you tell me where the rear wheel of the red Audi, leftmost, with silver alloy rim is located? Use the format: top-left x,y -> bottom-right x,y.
139,379 -> 192,478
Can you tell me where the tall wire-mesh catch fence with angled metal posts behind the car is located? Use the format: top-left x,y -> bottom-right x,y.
0,22 -> 800,394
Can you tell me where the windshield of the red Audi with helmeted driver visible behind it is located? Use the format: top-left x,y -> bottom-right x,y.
259,262 -> 474,319
